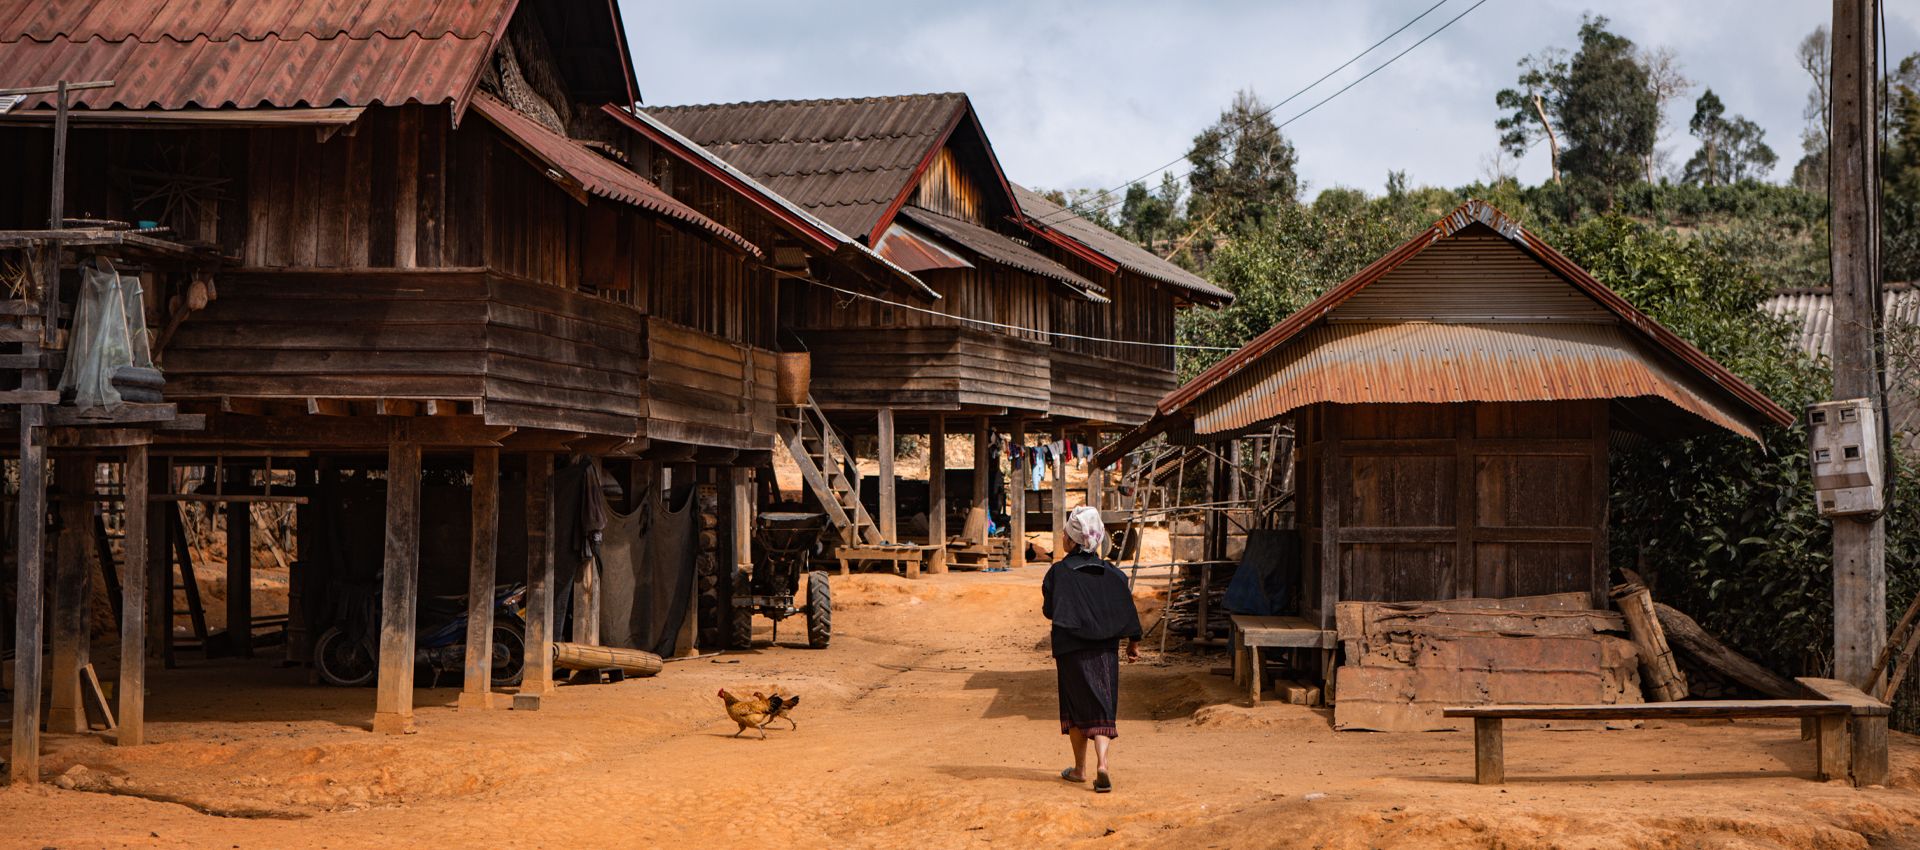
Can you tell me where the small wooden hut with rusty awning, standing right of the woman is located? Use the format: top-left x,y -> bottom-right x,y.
1098,201 -> 1793,686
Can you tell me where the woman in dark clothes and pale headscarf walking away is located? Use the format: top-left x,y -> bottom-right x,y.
1041,507 -> 1140,794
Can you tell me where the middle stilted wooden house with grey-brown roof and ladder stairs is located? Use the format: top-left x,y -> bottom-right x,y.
645,94 -> 1231,564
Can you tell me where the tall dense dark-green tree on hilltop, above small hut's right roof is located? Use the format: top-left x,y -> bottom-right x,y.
1561,17 -> 1659,207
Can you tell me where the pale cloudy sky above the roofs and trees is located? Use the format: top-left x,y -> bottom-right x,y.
620,0 -> 1920,203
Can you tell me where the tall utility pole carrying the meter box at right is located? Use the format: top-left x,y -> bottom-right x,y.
1828,0 -> 1887,691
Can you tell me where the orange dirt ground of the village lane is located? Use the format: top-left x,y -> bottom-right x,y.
0,566 -> 1920,850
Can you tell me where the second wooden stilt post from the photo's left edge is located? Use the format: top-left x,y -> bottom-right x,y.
46,455 -> 94,733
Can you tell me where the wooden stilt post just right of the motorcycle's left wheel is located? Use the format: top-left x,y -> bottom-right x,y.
370,432 -> 420,735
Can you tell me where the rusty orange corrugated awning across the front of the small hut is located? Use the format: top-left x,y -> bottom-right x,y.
1192,322 -> 1759,439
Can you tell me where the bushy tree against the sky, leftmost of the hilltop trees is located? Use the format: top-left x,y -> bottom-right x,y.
1187,90 -> 1300,232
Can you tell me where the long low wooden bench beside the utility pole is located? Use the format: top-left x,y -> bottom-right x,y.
1442,679 -> 1889,787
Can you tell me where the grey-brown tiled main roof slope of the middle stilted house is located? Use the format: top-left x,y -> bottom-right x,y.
647,94 -> 966,238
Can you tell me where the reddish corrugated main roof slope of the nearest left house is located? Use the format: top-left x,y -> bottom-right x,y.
0,0 -> 516,109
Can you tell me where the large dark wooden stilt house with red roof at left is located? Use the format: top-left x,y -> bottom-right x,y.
0,0 -> 817,781
